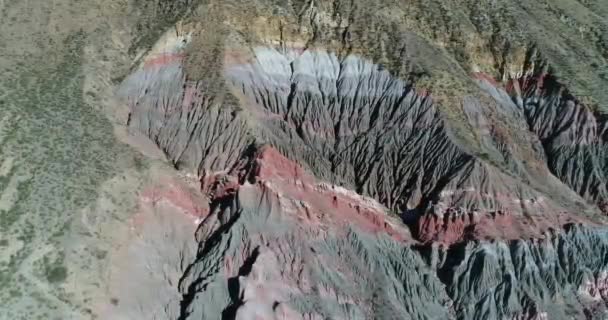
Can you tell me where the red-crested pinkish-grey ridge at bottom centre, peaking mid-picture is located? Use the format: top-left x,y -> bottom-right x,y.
173,148 -> 449,319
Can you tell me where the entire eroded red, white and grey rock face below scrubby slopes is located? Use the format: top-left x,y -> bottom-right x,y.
109,2 -> 608,319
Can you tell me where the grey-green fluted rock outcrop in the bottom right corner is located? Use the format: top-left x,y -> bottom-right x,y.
427,225 -> 607,319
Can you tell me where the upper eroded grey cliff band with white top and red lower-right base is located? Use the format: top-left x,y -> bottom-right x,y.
125,41 -> 600,243
